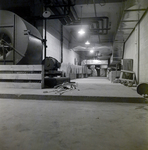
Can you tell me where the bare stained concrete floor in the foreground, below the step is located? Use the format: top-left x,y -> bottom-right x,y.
0,99 -> 148,150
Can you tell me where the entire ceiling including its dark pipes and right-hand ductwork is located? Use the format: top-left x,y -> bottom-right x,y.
0,0 -> 148,64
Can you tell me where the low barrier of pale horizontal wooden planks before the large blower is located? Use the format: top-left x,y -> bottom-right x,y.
0,65 -> 44,89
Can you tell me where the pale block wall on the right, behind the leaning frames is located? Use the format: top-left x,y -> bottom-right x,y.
123,10 -> 148,83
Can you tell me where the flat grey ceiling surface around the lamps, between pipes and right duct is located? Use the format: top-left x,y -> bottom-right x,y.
66,0 -> 123,60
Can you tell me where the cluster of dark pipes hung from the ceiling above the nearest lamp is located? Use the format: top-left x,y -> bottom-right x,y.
42,0 -> 109,30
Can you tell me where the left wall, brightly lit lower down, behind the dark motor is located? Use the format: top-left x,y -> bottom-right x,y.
43,19 -> 80,64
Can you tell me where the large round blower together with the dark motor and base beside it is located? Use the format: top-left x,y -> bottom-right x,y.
0,10 -> 70,87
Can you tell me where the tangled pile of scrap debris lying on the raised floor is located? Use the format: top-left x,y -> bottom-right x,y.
43,82 -> 78,95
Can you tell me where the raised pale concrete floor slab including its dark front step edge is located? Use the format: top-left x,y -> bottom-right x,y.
0,77 -> 145,103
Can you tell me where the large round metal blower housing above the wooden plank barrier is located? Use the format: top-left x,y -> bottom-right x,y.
0,10 -> 43,64
